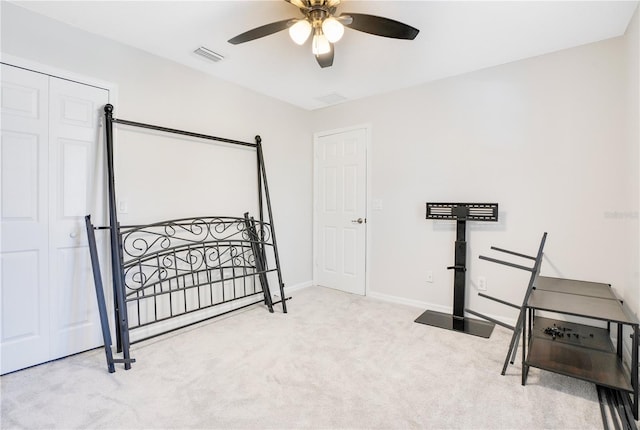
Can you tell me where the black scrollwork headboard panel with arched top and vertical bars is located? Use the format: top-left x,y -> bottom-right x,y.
120,217 -> 273,328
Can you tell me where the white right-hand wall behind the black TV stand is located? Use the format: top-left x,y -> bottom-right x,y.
313,25 -> 638,319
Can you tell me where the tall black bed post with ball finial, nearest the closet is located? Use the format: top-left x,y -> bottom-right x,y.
104,104 -> 132,370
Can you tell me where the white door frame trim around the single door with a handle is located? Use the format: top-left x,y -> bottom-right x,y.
312,123 -> 373,296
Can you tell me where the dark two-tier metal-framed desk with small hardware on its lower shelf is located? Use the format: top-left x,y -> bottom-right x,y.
522,276 -> 638,420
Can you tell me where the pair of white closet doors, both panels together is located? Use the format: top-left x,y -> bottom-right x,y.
0,65 -> 109,374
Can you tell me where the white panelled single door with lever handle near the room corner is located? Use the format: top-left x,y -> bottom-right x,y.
314,128 -> 368,295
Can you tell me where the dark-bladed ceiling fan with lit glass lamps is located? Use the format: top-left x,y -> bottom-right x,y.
229,0 -> 420,67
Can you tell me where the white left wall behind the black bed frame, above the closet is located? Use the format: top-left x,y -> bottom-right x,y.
1,2 -> 312,286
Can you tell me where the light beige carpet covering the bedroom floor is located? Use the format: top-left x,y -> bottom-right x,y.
0,287 -> 602,429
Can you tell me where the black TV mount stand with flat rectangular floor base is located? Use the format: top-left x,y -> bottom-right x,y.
415,203 -> 498,338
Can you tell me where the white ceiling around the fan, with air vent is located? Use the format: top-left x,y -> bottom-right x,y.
13,0 -> 638,109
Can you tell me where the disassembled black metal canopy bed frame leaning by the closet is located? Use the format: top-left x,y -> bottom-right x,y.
85,104 -> 287,373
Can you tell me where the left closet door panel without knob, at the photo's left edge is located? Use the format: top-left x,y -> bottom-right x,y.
0,66 -> 49,373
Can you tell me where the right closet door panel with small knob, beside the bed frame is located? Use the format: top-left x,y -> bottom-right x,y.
49,78 -> 108,359
